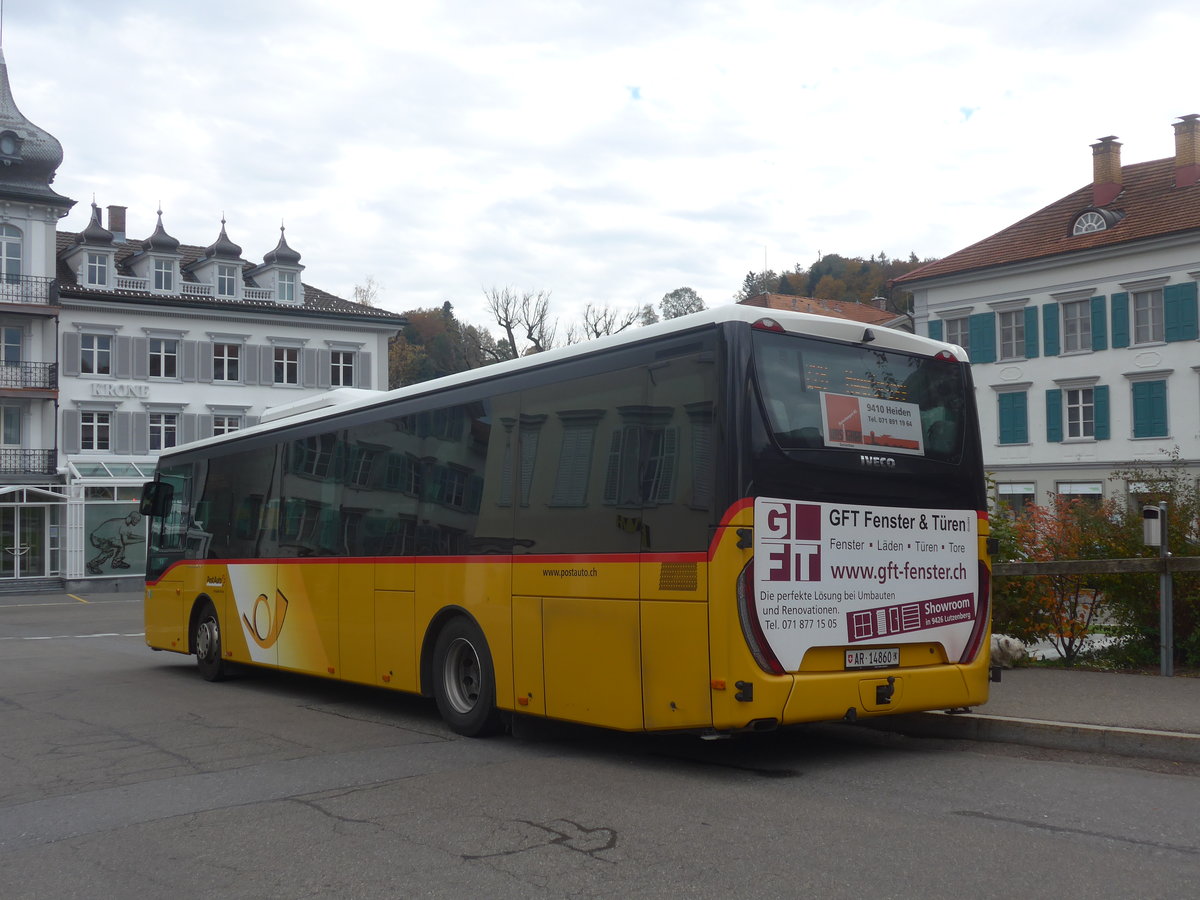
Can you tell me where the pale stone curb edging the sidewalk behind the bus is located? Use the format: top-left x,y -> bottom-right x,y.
858,712 -> 1200,762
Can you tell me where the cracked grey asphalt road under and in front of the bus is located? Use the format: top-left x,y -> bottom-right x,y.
0,595 -> 1200,900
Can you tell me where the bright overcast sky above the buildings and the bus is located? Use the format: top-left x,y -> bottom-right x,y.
4,0 -> 1200,325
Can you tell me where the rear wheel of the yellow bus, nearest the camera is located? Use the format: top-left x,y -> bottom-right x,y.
433,616 -> 502,738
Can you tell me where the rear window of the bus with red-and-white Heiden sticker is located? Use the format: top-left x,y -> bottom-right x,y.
754,331 -> 968,462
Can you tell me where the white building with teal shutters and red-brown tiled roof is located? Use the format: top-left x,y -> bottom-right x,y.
896,115 -> 1200,513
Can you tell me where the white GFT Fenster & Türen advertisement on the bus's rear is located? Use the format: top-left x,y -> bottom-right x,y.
754,497 -> 979,671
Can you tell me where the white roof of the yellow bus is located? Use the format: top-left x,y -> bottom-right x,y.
152,304 -> 967,458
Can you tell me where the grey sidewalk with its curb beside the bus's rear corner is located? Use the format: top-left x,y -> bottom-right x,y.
864,667 -> 1200,762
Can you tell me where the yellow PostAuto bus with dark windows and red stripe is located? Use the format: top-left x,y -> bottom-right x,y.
142,306 -> 990,736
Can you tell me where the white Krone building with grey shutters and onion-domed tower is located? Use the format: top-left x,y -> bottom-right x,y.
0,55 -> 403,590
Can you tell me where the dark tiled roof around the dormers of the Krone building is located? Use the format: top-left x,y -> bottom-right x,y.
56,232 -> 404,326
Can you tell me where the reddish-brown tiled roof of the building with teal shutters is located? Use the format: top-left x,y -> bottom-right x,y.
895,157 -> 1200,284
